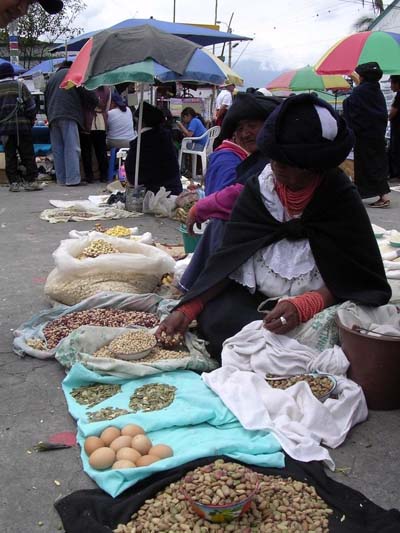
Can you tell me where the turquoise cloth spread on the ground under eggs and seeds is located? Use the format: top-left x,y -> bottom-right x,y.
63,364 -> 285,497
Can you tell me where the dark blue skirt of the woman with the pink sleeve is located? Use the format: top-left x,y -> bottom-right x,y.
180,218 -> 226,291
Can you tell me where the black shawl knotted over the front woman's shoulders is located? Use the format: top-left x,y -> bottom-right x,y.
181,169 -> 391,306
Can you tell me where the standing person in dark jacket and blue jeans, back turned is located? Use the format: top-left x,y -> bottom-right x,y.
44,61 -> 86,187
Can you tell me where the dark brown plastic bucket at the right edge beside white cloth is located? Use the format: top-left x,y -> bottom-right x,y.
336,318 -> 400,411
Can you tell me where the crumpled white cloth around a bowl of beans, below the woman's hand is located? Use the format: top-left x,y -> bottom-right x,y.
202,321 -> 368,469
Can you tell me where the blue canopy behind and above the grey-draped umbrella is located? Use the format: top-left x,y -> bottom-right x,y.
51,18 -> 252,52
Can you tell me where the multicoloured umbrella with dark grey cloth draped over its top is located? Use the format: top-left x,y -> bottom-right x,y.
62,25 -> 231,89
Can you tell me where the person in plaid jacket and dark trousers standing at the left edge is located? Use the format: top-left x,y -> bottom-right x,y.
0,62 -> 41,192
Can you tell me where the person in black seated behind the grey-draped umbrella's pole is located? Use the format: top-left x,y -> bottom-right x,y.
125,102 -> 182,195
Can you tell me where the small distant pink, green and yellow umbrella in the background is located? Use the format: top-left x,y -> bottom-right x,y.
266,66 -> 350,92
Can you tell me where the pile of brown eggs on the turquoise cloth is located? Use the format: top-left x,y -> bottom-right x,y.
84,424 -> 174,470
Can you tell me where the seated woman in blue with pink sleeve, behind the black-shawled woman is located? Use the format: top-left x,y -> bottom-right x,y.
180,94 -> 278,291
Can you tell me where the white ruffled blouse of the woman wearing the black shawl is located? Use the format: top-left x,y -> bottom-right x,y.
230,165 -> 324,297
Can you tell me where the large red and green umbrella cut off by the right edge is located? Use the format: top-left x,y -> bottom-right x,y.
314,31 -> 400,75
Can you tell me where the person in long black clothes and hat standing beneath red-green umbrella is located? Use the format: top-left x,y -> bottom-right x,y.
343,62 -> 390,207
